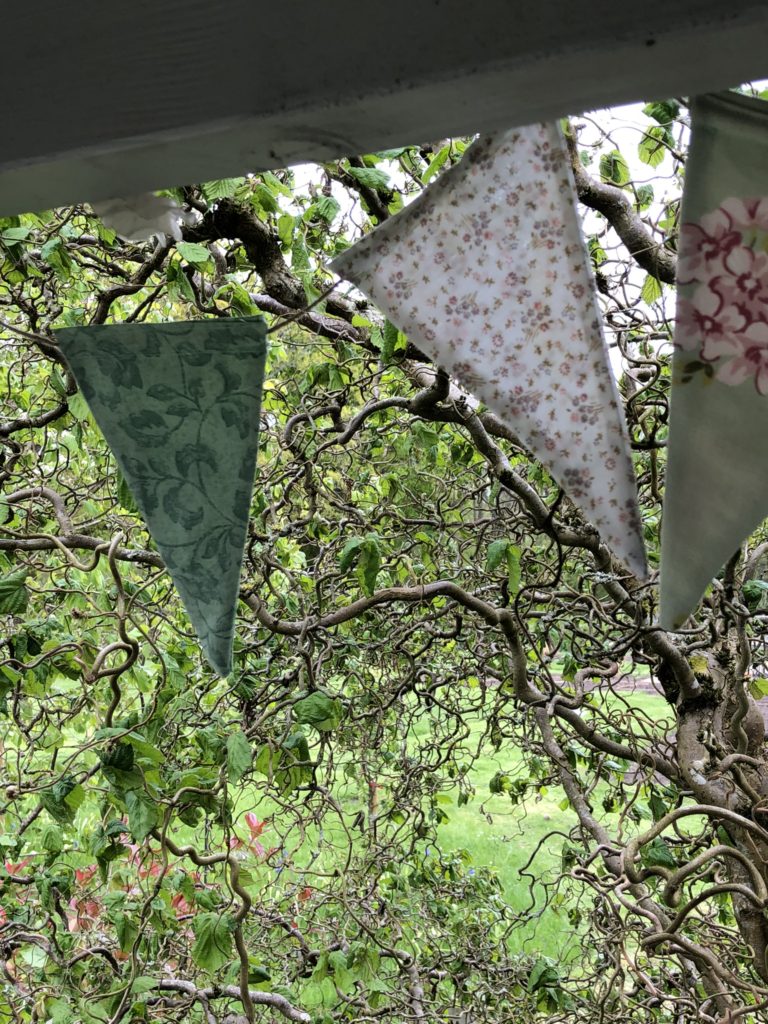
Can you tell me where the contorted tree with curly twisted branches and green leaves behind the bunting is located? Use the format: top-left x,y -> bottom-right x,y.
0,92 -> 768,1024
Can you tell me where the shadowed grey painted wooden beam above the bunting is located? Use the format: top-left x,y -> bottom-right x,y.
0,0 -> 768,215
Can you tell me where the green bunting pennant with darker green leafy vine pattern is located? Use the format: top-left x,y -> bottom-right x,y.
56,317 -> 266,676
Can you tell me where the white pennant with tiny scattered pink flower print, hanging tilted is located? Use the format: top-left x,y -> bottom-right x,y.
331,125 -> 646,578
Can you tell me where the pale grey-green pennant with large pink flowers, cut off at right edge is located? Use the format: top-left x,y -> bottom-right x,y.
660,93 -> 768,629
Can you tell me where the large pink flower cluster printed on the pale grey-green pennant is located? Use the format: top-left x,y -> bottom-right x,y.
675,197 -> 768,395
